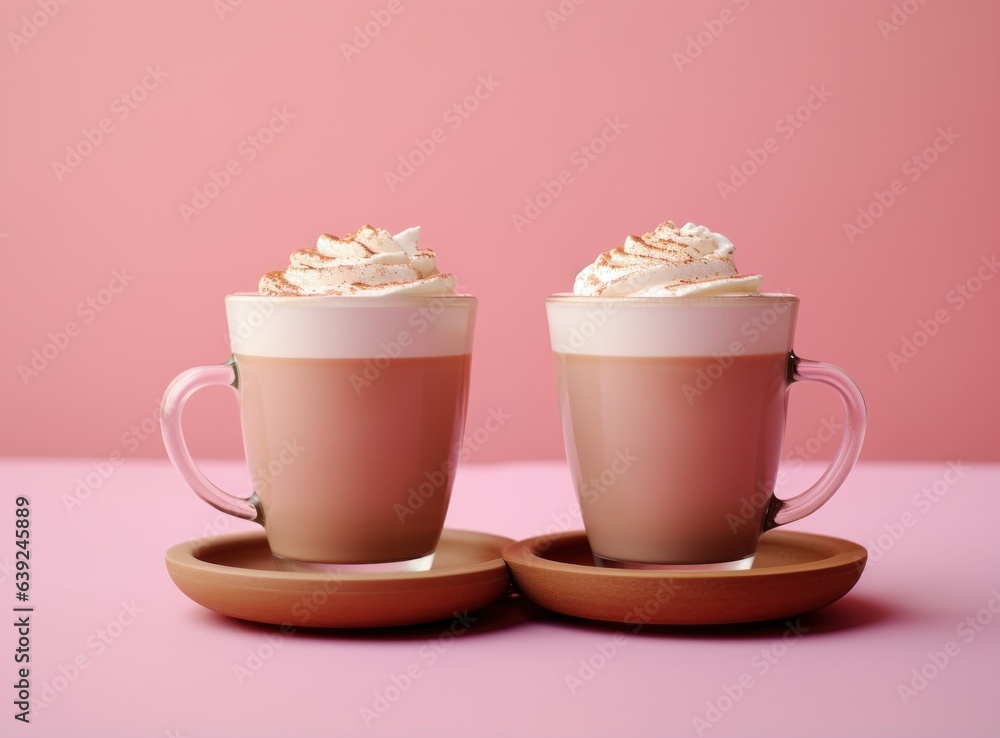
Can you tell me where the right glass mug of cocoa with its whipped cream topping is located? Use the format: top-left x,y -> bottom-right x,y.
546,221 -> 866,570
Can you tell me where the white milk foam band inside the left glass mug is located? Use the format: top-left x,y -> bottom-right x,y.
226,293 -> 476,359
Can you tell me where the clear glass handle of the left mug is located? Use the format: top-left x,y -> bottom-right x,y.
160,357 -> 263,523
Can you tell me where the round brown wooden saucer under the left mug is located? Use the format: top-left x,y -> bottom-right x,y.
166,530 -> 512,628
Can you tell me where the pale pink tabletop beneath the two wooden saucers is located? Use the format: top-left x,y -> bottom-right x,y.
0,459 -> 1000,738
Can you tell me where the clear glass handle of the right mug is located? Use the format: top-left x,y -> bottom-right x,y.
762,353 -> 868,531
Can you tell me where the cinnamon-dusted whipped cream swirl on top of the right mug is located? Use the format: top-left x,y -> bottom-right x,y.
573,220 -> 761,297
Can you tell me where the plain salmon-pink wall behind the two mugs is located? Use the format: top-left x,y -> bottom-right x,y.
0,0 -> 1000,461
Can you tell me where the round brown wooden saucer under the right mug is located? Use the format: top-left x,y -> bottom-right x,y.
503,530 -> 868,626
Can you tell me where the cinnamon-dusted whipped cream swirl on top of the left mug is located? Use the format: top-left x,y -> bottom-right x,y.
258,225 -> 456,296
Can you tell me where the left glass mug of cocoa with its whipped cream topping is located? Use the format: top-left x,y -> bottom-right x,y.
161,226 -> 477,572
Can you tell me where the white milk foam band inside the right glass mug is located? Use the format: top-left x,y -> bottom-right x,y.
545,294 -> 799,357
